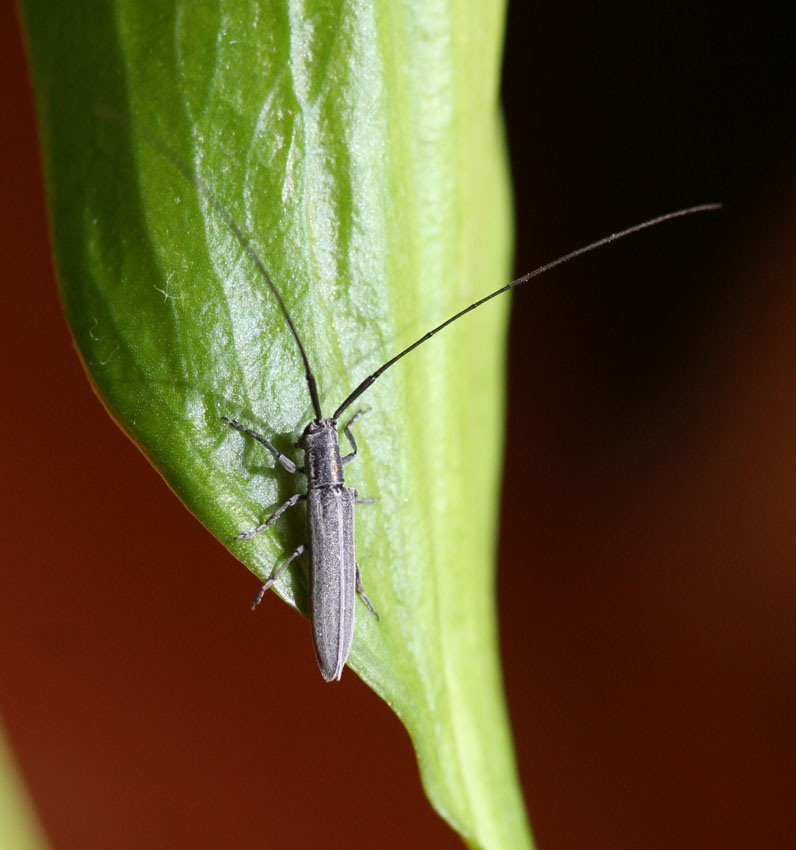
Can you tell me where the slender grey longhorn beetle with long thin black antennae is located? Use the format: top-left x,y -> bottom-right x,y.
207,195 -> 720,682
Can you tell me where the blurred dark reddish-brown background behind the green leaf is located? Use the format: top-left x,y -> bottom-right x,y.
0,2 -> 796,850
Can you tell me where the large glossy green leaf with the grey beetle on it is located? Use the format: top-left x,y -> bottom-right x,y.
22,0 -> 531,850
